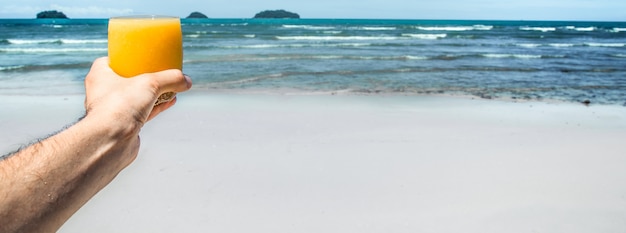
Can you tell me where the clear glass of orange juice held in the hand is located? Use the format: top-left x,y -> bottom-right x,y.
108,15 -> 183,105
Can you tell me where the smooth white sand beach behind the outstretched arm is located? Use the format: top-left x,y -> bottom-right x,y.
0,91 -> 626,233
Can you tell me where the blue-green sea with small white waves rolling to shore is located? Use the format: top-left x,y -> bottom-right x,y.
0,19 -> 626,106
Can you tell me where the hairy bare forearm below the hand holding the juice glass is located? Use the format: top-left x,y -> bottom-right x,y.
0,116 -> 139,232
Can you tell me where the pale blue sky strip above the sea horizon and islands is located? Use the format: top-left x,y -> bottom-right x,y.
0,0 -> 626,21
